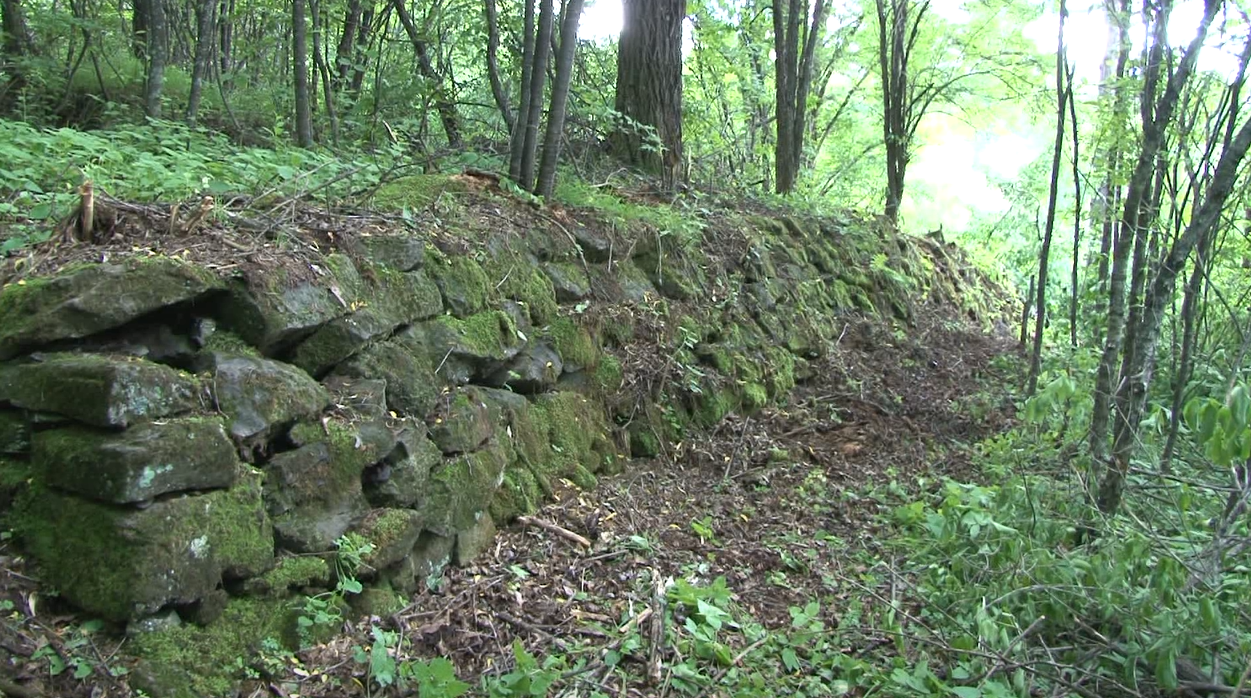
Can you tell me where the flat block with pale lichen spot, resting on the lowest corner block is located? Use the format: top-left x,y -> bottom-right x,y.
31,417 -> 239,504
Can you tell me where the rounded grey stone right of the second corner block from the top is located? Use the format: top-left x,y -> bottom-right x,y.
208,354 -> 330,442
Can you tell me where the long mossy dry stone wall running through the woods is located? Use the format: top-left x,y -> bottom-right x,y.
0,205 -> 990,694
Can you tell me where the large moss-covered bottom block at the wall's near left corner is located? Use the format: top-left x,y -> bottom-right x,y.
18,467 -> 274,620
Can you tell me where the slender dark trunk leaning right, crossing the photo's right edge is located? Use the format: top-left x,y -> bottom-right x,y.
1098,109 -> 1251,514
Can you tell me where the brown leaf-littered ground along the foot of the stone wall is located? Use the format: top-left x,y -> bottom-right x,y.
0,185 -> 1020,698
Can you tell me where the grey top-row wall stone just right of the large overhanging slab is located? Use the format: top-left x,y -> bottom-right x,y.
218,254 -> 362,357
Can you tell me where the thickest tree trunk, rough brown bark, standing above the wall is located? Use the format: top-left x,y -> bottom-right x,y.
613,0 -> 687,189
